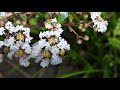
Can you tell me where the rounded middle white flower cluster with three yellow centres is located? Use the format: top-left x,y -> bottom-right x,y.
31,22 -> 70,67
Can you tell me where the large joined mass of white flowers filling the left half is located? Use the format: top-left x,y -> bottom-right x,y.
0,18 -> 70,67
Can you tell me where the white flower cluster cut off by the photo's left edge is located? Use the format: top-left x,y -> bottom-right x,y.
0,21 -> 33,67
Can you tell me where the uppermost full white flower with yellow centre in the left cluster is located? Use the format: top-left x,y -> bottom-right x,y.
5,21 -> 33,43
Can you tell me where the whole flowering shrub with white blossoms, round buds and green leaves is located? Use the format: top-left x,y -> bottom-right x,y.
0,12 -> 108,67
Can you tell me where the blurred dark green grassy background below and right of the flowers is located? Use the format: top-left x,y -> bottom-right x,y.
0,12 -> 120,78
